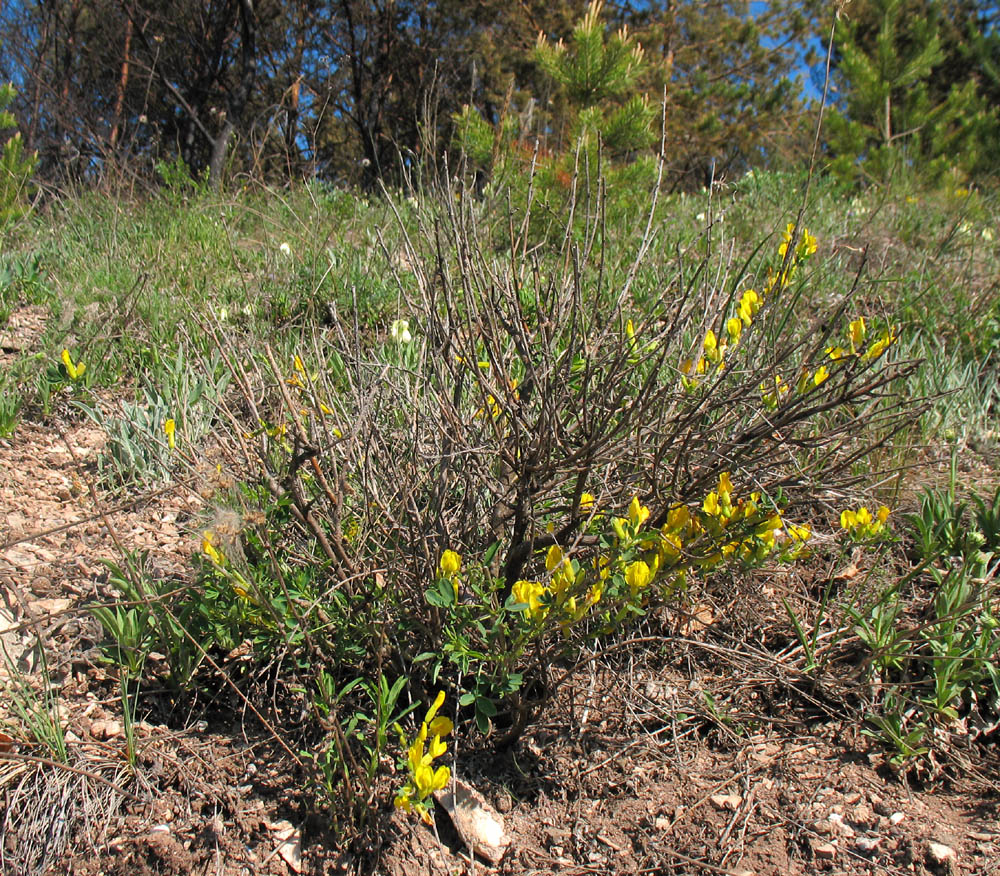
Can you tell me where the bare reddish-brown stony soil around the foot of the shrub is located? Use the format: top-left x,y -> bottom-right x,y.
0,302 -> 1000,876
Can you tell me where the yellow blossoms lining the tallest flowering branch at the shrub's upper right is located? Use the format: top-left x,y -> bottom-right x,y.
680,222 -> 816,392
